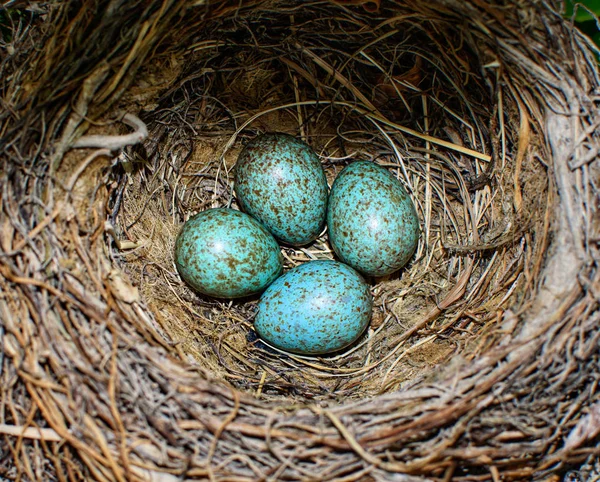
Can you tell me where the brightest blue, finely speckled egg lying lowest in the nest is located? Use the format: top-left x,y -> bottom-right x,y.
254,261 -> 373,355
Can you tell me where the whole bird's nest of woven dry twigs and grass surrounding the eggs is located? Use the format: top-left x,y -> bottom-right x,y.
0,0 -> 600,481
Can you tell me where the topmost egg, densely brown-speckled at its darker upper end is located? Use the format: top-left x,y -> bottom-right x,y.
235,133 -> 328,246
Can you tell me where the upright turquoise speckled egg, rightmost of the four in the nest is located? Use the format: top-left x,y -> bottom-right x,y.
327,161 -> 419,276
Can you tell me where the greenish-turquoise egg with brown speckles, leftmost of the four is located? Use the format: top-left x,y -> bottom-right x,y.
175,208 -> 283,298
